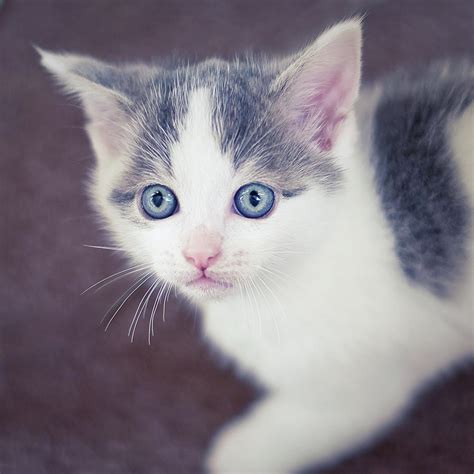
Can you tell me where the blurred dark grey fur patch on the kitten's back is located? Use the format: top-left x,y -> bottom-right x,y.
372,63 -> 474,296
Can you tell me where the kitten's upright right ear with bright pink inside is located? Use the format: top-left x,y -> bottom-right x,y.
272,20 -> 362,151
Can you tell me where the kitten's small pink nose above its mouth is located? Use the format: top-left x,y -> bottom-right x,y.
183,227 -> 222,270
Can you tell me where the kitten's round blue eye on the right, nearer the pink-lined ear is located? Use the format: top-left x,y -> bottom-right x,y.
234,183 -> 275,219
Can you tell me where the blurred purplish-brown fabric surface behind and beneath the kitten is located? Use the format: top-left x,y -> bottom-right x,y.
0,0 -> 474,474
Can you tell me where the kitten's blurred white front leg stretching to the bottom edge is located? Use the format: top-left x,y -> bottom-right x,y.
207,384 -> 407,474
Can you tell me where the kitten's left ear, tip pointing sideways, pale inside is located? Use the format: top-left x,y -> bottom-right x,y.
36,47 -> 131,159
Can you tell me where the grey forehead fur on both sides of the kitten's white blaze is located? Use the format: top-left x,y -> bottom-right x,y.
114,58 -> 342,196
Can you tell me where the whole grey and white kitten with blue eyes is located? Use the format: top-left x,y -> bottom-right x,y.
40,20 -> 474,473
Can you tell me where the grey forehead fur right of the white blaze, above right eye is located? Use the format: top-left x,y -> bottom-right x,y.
209,58 -> 342,196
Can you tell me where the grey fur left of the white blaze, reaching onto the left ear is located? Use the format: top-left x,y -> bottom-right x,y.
75,60 -> 190,181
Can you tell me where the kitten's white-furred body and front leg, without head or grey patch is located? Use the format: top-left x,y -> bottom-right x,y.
203,67 -> 474,472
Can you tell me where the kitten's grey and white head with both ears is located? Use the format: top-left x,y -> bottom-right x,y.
40,20 -> 361,299
